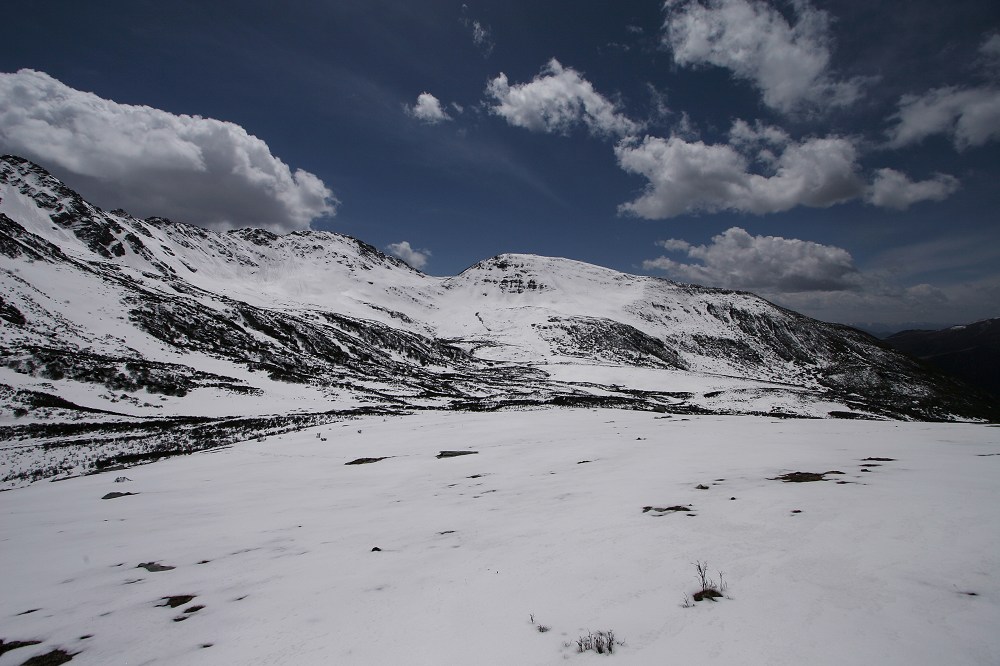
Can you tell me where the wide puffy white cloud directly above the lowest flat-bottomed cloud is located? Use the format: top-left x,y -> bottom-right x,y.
615,123 -> 864,219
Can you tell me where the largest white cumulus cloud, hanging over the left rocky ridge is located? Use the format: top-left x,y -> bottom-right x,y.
0,69 -> 339,232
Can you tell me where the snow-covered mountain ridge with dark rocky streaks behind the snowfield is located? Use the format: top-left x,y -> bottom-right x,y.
0,156 -> 995,482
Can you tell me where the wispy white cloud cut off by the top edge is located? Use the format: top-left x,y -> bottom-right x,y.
662,0 -> 863,113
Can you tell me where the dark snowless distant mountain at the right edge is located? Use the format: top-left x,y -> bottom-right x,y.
885,318 -> 1000,396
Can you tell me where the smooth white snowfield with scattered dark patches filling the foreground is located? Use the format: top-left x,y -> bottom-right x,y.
0,409 -> 1000,666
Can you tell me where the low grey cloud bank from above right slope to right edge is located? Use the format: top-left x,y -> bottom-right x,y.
643,227 -> 1000,323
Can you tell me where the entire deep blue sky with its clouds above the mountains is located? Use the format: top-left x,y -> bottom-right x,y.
0,0 -> 1000,327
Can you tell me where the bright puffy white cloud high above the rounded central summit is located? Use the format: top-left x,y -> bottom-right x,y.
486,58 -> 639,136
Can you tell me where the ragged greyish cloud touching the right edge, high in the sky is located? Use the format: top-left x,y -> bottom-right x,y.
889,86 -> 1000,150
